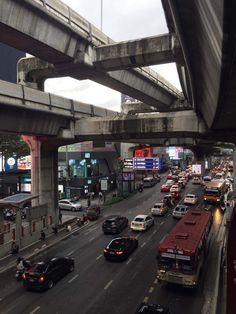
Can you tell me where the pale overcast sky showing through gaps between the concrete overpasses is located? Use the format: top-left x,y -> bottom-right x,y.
45,0 -> 181,111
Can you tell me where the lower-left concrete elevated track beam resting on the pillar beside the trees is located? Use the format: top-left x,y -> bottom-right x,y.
0,80 -> 115,136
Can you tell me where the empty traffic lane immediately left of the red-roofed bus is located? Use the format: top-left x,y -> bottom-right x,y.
82,212 -> 179,314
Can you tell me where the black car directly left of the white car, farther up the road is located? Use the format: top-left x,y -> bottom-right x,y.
102,215 -> 129,234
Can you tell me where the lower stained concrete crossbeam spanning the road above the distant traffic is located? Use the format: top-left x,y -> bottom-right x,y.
75,110 -> 207,142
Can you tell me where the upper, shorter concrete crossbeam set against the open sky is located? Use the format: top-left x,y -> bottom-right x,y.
94,34 -> 180,71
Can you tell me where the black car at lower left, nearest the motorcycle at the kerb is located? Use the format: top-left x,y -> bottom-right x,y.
23,257 -> 74,290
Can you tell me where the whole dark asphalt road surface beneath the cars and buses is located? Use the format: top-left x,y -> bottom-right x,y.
0,180 -> 225,314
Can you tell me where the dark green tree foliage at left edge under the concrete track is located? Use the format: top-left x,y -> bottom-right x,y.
0,134 -> 30,158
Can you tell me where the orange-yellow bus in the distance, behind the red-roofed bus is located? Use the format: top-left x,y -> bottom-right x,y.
204,180 -> 227,204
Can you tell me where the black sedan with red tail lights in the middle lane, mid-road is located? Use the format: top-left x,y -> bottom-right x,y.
103,237 -> 138,261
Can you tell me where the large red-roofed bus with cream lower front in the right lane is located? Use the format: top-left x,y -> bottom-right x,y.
157,210 -> 212,288
